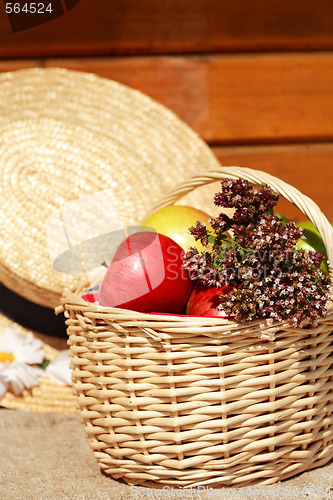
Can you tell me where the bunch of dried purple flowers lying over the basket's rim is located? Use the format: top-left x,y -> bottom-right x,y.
184,179 -> 330,326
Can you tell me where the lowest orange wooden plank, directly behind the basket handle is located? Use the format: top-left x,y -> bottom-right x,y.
213,143 -> 333,223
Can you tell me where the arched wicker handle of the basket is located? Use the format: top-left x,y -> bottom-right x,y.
152,167 -> 333,285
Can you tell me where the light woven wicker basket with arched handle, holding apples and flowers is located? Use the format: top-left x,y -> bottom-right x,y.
62,167 -> 333,487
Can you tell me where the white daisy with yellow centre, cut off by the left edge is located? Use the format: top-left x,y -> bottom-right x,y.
0,326 -> 45,397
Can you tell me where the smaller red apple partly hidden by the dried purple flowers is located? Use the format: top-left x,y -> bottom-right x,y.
186,284 -> 233,318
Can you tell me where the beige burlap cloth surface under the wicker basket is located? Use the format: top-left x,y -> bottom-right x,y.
0,409 -> 333,500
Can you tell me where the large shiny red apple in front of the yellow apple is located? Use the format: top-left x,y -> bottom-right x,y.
99,231 -> 193,313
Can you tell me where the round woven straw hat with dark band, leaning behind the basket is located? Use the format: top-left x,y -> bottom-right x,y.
0,69 -> 222,410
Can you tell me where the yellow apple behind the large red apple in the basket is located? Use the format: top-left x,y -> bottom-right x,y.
141,205 -> 211,251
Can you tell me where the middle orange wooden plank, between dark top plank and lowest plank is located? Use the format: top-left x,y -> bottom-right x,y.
45,52 -> 333,144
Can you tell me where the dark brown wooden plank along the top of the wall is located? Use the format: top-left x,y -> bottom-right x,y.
0,0 -> 333,58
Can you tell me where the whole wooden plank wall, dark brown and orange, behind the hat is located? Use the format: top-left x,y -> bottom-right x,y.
0,0 -> 333,221
